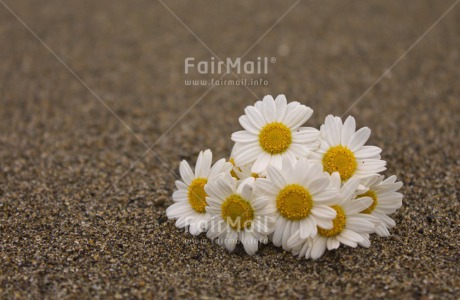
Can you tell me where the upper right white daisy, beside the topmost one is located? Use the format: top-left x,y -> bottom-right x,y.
310,115 -> 386,181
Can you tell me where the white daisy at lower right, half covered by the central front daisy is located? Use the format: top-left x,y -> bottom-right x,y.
288,172 -> 378,259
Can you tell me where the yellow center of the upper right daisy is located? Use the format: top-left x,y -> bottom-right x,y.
323,145 -> 358,181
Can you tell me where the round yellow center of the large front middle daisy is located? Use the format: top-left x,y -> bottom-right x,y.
276,184 -> 313,221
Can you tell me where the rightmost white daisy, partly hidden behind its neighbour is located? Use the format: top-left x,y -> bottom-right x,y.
358,175 -> 403,237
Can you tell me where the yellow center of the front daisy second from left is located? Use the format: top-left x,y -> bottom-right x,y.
222,195 -> 254,230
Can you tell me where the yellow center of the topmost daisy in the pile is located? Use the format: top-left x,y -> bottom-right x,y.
259,122 -> 292,154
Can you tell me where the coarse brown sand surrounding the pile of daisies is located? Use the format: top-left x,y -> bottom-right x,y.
0,0 -> 460,299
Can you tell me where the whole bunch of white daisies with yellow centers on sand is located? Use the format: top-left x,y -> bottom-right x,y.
166,95 -> 403,259
